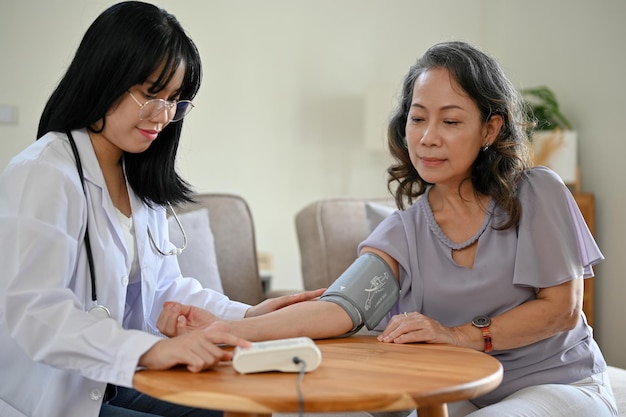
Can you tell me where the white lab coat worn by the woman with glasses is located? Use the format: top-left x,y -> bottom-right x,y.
0,130 -> 249,417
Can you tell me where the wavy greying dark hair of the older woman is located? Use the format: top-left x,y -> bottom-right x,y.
387,42 -> 531,229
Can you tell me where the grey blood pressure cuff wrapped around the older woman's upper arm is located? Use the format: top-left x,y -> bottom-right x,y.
320,252 -> 400,336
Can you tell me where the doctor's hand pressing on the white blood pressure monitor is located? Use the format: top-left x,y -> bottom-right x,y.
139,330 -> 250,372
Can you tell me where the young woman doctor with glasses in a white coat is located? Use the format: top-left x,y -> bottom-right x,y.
0,2 -> 319,417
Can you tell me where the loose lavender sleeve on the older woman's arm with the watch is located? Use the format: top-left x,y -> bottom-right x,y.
514,167 -> 604,288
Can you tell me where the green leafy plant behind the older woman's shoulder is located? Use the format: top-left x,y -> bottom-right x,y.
520,86 -> 572,130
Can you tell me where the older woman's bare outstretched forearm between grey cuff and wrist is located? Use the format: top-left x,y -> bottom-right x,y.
228,301 -> 352,341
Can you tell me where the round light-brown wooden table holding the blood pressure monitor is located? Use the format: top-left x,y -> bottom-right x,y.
134,336 -> 502,417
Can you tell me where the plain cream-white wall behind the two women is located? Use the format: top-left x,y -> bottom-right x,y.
0,0 -> 626,366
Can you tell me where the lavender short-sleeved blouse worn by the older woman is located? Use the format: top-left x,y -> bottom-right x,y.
359,167 -> 606,406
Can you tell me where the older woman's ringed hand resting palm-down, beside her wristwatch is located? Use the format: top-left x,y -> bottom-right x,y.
377,312 -> 459,345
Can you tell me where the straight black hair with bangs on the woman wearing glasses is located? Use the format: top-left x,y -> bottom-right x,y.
37,1 -> 202,205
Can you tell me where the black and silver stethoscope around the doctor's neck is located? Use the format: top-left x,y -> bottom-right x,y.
65,130 -> 187,319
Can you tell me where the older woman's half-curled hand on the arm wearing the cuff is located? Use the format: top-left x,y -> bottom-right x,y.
157,301 -> 218,337
